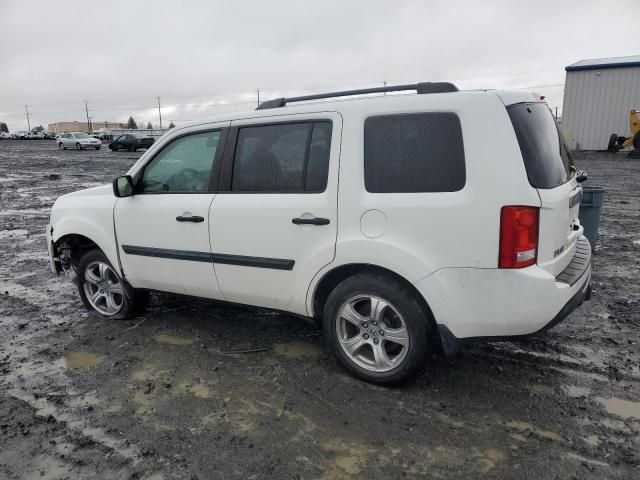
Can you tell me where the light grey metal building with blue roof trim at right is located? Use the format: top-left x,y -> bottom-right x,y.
561,55 -> 640,150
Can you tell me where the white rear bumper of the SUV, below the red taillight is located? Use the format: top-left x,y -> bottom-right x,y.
415,237 -> 591,343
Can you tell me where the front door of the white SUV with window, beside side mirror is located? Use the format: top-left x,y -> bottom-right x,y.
115,122 -> 228,298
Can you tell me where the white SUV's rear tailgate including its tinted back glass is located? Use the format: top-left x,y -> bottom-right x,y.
507,102 -> 584,276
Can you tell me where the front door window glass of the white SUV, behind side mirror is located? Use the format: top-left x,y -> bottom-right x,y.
139,131 -> 221,193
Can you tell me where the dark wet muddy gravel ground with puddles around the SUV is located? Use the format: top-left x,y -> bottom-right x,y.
0,141 -> 640,480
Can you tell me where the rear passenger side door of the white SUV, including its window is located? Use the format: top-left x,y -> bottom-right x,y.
209,113 -> 342,314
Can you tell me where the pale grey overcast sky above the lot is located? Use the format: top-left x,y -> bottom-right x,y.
0,0 -> 640,130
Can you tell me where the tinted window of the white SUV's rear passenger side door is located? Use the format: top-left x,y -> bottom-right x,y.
231,121 -> 331,193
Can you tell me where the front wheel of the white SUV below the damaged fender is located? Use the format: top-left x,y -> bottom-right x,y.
76,248 -> 149,320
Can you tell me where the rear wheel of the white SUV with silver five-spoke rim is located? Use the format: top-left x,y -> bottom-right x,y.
322,273 -> 435,385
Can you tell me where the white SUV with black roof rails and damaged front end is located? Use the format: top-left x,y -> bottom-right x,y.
47,83 -> 591,384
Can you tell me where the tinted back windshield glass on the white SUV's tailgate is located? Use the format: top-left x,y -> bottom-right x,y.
507,103 -> 573,188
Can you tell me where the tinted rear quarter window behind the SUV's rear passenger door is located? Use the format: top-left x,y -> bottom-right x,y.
364,112 -> 466,193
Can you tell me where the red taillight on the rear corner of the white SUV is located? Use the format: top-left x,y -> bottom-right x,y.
498,207 -> 539,268
